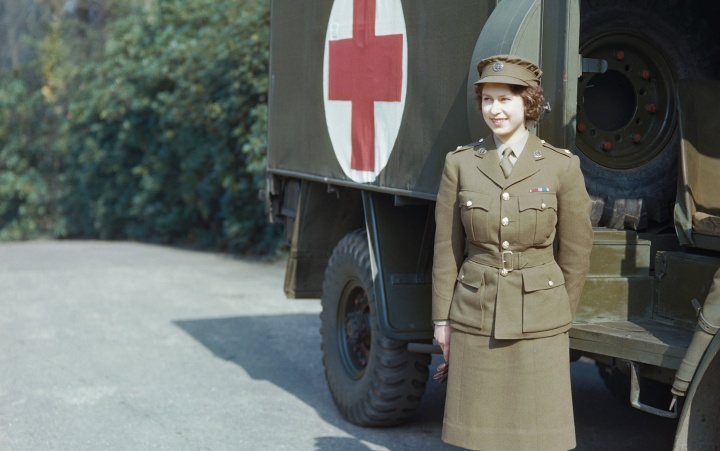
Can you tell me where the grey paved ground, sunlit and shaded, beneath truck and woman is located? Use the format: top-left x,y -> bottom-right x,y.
0,242 -> 674,451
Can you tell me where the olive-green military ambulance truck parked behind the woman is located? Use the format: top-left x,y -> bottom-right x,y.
266,0 -> 720,449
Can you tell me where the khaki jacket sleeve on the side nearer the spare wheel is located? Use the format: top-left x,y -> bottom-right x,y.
557,155 -> 593,316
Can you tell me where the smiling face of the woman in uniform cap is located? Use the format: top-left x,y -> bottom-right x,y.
482,83 -> 525,142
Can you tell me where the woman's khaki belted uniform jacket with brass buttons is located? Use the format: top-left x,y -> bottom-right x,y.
433,134 -> 593,339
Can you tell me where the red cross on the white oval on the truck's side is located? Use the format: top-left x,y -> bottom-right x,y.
328,0 -> 403,171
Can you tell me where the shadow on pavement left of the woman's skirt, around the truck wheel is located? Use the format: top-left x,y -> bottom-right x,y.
175,314 -> 457,451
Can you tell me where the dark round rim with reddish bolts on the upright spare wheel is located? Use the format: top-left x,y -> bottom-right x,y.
576,32 -> 676,169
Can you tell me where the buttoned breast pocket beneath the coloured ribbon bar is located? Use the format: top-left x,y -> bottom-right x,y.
518,193 -> 557,245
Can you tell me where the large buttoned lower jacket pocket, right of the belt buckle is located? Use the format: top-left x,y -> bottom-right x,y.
522,262 -> 572,332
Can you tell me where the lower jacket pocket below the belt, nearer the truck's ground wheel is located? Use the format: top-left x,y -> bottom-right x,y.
450,260 -> 485,329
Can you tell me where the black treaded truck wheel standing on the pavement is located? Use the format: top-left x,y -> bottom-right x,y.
320,230 -> 430,426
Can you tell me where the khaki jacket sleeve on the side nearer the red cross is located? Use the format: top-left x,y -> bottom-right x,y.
432,153 -> 465,321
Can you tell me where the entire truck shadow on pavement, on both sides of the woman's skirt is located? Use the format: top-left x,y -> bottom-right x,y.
175,314 -> 676,451
